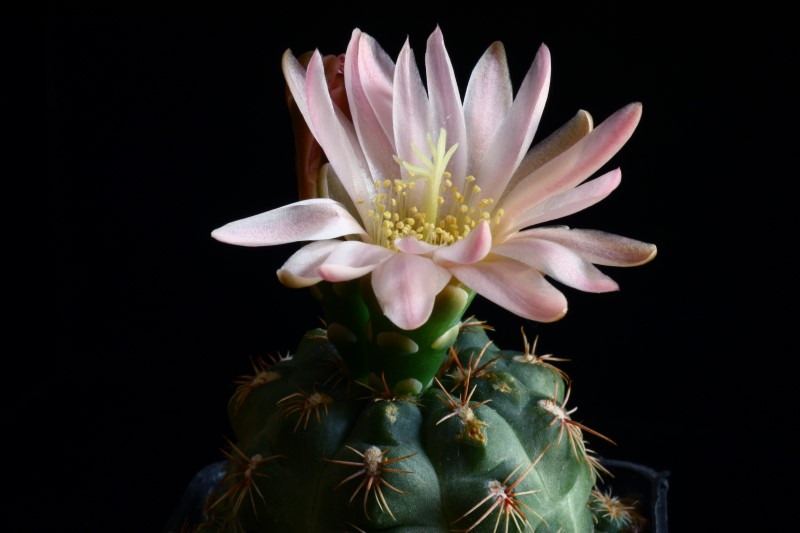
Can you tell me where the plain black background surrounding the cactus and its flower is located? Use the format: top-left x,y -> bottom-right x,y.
39,7 -> 797,533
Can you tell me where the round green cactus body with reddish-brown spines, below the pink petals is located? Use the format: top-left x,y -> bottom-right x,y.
198,285 -> 625,533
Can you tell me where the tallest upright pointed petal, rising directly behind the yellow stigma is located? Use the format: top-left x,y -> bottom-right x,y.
425,26 -> 468,188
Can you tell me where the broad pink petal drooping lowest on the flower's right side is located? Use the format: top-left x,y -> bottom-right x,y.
448,260 -> 567,322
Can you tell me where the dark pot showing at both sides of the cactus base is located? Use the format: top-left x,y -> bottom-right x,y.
163,459 -> 669,533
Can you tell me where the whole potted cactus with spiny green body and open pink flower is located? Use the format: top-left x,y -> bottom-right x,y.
198,28 -> 656,533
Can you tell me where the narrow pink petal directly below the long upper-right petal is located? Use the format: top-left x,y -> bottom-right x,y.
498,168 -> 622,236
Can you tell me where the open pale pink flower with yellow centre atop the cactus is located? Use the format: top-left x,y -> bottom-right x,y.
212,28 -> 656,330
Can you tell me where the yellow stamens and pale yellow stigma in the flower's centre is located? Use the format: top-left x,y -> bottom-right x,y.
367,128 -> 503,250
